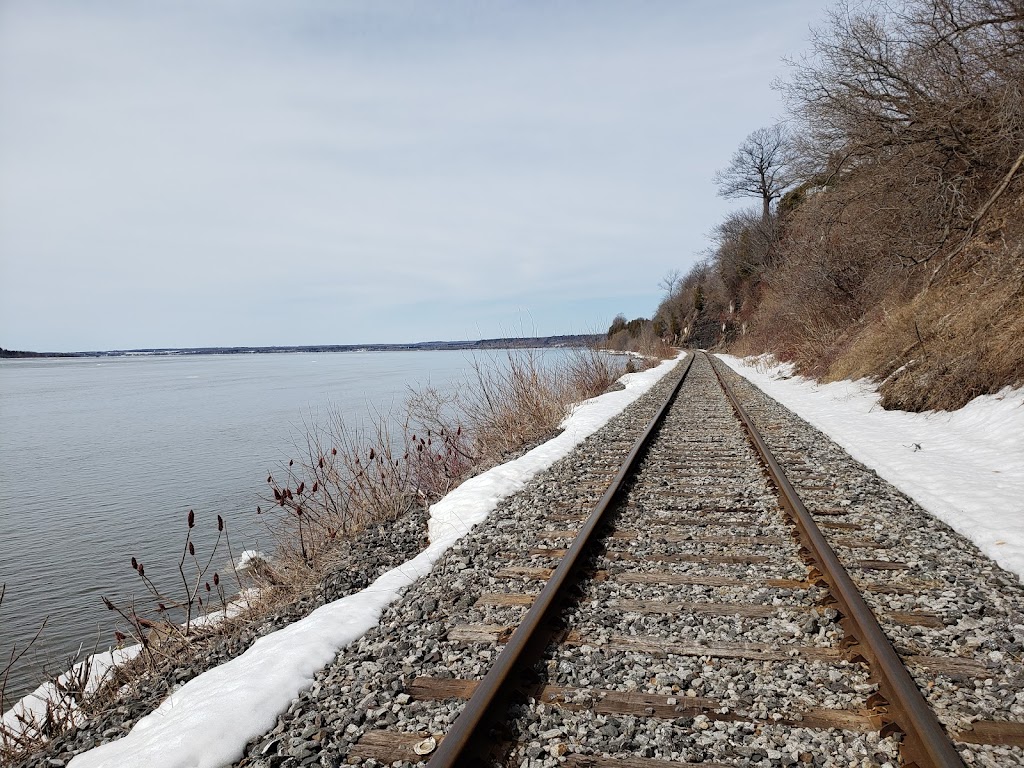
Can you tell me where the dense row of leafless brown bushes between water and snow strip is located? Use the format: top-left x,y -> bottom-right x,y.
257,349 -> 622,586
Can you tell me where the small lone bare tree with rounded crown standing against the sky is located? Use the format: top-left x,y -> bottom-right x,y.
715,123 -> 790,221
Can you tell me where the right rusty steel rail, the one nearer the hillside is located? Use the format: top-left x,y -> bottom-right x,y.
703,352 -> 965,768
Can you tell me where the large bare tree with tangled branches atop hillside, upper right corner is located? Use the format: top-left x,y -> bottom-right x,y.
779,0 -> 1024,267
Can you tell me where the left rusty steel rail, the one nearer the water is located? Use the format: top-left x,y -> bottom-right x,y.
427,352 -> 694,768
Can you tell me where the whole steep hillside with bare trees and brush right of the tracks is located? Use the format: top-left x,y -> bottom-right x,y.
626,0 -> 1024,411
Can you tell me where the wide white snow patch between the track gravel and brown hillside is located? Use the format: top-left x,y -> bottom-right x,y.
719,355 -> 1024,582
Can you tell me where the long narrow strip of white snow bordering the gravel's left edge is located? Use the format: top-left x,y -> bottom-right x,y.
61,355 -> 682,768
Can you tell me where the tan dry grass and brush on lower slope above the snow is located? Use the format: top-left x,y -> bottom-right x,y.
730,194 -> 1024,411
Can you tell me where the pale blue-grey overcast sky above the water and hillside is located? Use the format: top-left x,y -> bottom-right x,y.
0,0 -> 826,351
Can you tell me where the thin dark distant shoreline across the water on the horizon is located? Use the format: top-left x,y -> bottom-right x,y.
0,334 -> 604,359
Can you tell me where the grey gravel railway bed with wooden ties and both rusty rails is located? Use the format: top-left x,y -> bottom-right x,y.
242,354 -> 1024,768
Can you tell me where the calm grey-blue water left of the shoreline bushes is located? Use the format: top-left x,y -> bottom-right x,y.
0,351 -> 495,706
